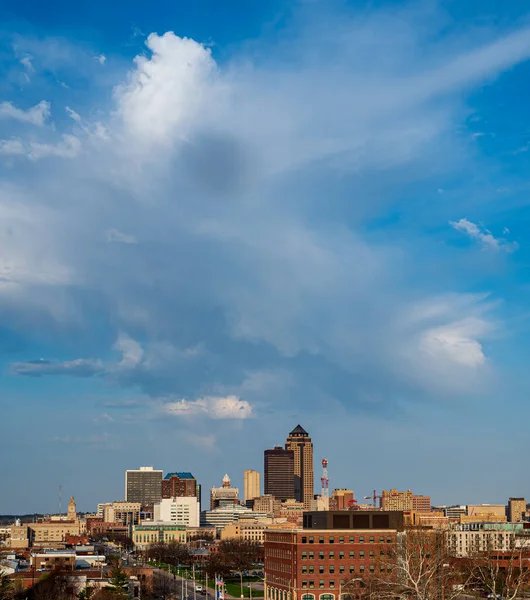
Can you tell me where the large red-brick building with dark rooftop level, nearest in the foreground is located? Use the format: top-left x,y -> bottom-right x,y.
265,511 -> 403,600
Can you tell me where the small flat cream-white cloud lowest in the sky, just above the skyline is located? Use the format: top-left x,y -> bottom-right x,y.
162,396 -> 254,419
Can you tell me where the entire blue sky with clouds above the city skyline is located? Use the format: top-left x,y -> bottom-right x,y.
0,0 -> 530,514
